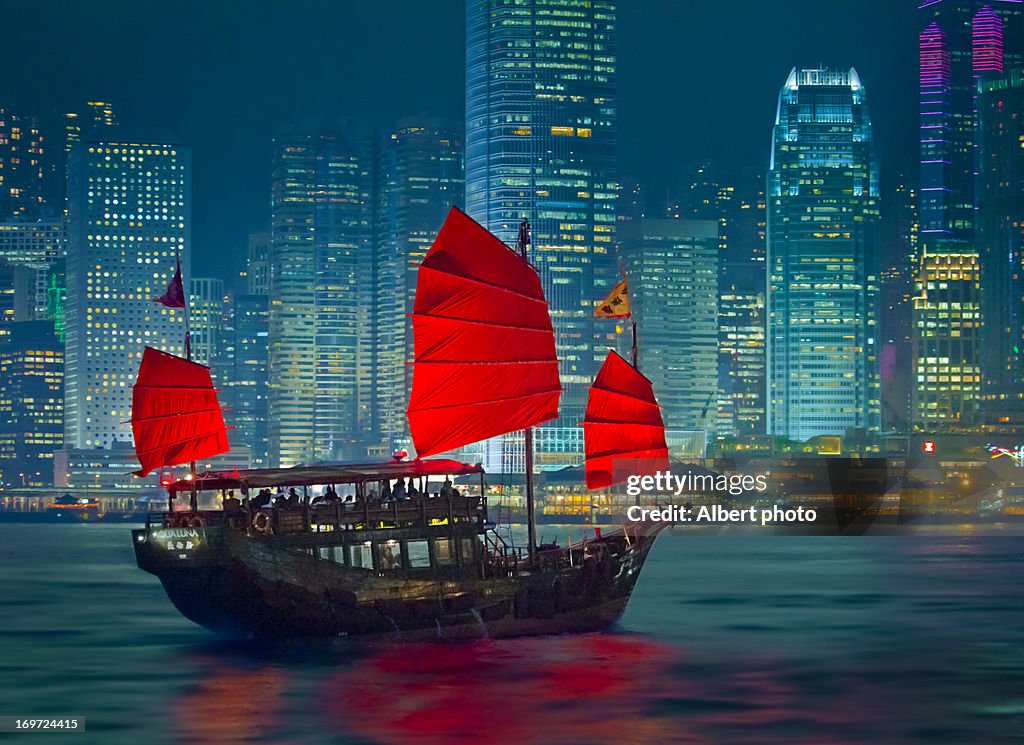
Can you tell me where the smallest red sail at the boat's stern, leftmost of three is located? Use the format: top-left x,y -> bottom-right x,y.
131,347 -> 230,476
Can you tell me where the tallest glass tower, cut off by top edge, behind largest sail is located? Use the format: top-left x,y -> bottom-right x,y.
466,0 -> 617,435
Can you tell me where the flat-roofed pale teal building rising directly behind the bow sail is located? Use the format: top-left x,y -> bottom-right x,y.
605,218 -> 719,430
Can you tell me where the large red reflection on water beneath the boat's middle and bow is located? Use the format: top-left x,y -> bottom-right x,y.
323,634 -> 699,745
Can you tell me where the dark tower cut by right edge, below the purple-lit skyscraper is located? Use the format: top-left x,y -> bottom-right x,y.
977,68 -> 1024,409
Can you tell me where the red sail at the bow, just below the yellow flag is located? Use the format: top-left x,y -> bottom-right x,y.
583,351 -> 669,489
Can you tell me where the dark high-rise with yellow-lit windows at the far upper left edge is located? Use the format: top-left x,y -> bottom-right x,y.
0,106 -> 46,220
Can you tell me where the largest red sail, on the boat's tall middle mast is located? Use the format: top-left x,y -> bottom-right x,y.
408,209 -> 561,457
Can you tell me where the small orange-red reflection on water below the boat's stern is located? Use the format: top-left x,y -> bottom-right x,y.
173,667 -> 286,743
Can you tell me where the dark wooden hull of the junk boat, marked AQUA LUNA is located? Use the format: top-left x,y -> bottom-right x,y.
133,527 -> 656,640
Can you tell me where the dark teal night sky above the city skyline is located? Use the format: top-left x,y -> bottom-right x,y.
0,0 -> 918,276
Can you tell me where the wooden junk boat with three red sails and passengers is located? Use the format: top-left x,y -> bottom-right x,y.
133,210 -> 664,639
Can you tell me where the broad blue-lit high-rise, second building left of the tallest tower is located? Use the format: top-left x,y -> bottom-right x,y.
269,122 -> 373,467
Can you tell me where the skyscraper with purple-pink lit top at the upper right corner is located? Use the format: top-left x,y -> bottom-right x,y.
919,0 -> 1024,251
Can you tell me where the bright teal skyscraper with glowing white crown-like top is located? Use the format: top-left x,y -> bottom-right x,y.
768,69 -> 880,440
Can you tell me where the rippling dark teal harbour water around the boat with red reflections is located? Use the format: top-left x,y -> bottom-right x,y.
0,525 -> 1024,745
